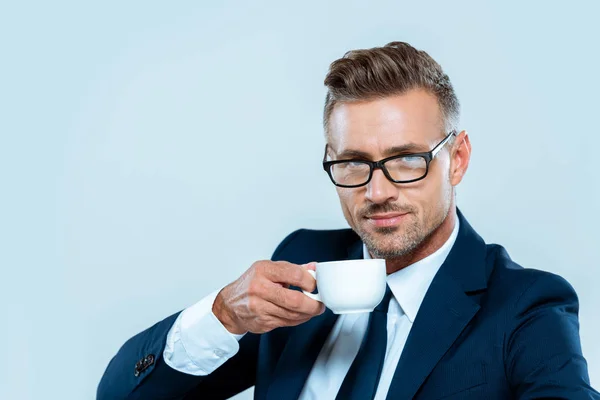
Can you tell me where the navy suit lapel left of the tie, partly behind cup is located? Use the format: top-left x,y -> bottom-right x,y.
266,236 -> 363,400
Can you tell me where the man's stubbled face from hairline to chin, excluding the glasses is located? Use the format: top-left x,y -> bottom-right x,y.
328,90 -> 460,259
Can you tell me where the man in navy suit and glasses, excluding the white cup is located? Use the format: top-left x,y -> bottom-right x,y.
98,42 -> 600,400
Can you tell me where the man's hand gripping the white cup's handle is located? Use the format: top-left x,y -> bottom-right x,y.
212,261 -> 325,334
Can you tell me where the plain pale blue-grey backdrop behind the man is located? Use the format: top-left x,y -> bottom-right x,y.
0,1 -> 600,400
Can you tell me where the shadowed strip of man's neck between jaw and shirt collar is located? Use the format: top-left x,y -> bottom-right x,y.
386,204 -> 457,275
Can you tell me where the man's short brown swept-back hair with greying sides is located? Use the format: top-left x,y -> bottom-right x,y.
323,42 -> 460,134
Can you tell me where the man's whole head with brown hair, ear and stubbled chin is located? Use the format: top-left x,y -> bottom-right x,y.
323,42 -> 470,259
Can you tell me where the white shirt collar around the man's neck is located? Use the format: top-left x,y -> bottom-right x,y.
363,214 -> 460,323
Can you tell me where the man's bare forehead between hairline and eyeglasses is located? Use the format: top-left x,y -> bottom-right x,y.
328,90 -> 443,156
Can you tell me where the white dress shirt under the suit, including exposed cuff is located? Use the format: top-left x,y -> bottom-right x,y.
163,218 -> 459,400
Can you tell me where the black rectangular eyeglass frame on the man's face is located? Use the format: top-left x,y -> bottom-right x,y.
323,130 -> 456,188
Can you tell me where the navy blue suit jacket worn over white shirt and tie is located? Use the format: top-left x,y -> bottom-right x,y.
97,212 -> 600,400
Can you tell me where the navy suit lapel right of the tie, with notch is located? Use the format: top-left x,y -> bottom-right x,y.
387,210 -> 490,399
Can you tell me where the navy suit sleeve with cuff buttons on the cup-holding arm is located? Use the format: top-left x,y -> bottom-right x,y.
97,231 -> 298,400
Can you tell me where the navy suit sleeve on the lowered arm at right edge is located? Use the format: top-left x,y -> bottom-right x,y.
506,273 -> 600,399
